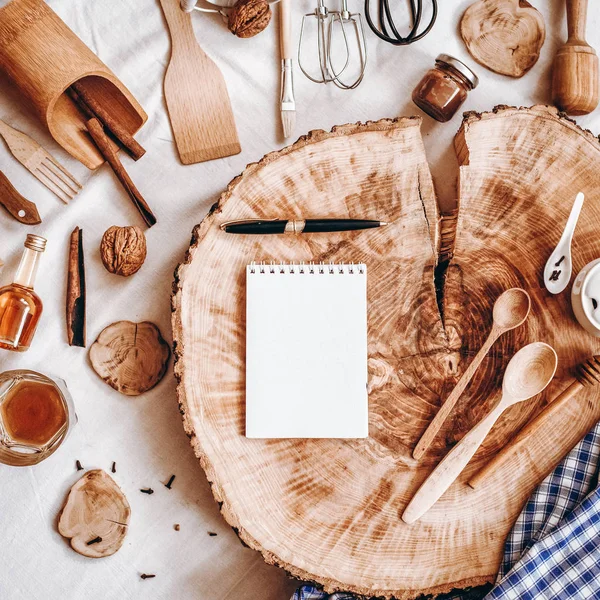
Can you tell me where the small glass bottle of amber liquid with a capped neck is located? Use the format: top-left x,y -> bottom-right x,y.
0,234 -> 46,352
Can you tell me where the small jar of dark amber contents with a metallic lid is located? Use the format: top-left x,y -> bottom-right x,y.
412,54 -> 479,123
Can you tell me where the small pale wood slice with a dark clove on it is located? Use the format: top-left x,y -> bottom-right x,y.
58,469 -> 131,558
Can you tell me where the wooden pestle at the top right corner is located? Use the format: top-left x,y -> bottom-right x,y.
552,0 -> 598,115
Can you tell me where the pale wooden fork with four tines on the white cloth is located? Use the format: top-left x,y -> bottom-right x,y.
0,119 -> 82,204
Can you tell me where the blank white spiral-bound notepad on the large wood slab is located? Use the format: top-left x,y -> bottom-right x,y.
246,264 -> 368,438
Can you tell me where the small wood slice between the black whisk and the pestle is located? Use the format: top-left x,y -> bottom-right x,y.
460,0 -> 546,77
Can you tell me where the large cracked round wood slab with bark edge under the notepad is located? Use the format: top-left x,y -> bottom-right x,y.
173,107 -> 600,598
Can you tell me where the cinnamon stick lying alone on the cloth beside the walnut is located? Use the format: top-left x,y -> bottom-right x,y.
67,227 -> 85,346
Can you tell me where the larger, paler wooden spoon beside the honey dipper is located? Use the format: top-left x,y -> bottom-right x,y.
402,342 -> 558,523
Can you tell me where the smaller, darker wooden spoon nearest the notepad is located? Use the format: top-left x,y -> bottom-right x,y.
413,288 -> 531,460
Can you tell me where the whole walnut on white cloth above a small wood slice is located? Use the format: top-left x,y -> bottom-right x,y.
100,225 -> 146,277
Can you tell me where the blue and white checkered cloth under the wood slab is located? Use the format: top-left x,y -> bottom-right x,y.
292,423 -> 600,600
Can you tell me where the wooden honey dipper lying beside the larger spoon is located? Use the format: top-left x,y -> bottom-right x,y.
469,355 -> 600,488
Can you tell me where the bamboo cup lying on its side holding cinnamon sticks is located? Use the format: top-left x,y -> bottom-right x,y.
0,0 -> 148,169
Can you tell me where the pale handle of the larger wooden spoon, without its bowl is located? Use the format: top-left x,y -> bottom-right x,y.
402,400 -> 507,523
